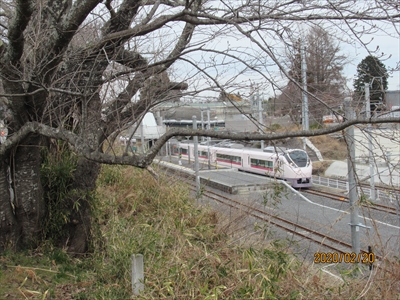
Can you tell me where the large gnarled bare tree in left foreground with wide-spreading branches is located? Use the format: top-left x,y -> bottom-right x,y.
0,0 -> 400,253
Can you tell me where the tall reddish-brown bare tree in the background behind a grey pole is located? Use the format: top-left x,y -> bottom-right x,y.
279,25 -> 346,122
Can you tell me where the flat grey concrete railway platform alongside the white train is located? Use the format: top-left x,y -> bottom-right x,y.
155,157 -> 272,195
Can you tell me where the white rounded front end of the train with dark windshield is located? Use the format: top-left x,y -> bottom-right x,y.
283,149 -> 312,188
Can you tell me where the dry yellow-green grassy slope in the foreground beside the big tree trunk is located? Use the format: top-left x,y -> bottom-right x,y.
0,166 -> 400,299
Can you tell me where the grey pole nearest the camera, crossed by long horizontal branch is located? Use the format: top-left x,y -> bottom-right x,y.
344,97 -> 360,254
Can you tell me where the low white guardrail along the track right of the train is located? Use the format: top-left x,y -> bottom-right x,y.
312,176 -> 400,202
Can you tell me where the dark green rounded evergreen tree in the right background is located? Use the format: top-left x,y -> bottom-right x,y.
354,55 -> 389,111
